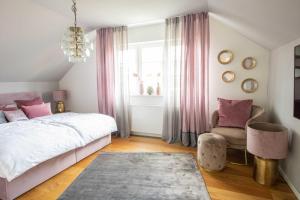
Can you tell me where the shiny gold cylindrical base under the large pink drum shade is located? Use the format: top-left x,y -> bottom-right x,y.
253,156 -> 278,186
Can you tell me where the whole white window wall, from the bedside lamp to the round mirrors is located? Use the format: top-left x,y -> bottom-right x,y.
59,18 -> 269,135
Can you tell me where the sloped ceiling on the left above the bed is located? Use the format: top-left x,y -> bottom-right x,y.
0,0 -> 71,82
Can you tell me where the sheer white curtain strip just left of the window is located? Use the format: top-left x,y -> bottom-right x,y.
113,26 -> 131,137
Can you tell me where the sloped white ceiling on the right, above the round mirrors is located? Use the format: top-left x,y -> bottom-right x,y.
208,0 -> 300,49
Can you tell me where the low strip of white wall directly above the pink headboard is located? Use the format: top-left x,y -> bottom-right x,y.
0,82 -> 58,102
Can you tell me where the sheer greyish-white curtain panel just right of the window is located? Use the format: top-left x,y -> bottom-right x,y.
162,17 -> 181,143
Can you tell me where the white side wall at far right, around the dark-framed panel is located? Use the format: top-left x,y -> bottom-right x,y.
269,38 -> 300,198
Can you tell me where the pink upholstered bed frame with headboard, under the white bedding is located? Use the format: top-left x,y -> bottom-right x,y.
0,92 -> 111,200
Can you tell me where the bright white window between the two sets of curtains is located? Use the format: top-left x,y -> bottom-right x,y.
126,41 -> 163,95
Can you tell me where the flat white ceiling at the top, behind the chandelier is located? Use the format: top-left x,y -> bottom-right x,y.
33,0 -> 207,29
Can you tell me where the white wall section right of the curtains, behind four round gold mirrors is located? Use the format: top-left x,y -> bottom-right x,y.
209,17 -> 270,117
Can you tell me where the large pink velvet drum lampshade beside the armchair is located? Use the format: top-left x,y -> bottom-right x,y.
247,122 -> 288,159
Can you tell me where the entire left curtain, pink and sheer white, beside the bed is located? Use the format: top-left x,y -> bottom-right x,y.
96,26 -> 131,137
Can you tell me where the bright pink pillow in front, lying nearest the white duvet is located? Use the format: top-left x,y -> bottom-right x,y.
22,103 -> 52,119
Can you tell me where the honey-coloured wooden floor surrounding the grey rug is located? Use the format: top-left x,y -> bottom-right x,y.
18,136 -> 297,200
